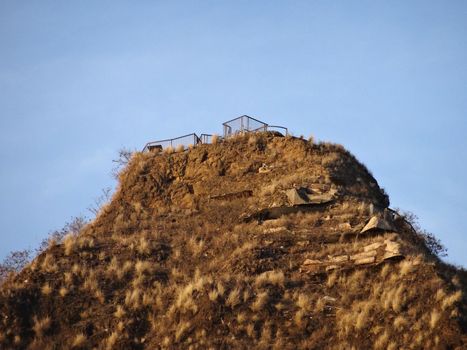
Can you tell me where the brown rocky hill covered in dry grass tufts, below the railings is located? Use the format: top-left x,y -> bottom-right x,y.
0,133 -> 466,349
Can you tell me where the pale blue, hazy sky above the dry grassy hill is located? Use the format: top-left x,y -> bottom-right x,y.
0,0 -> 467,266
